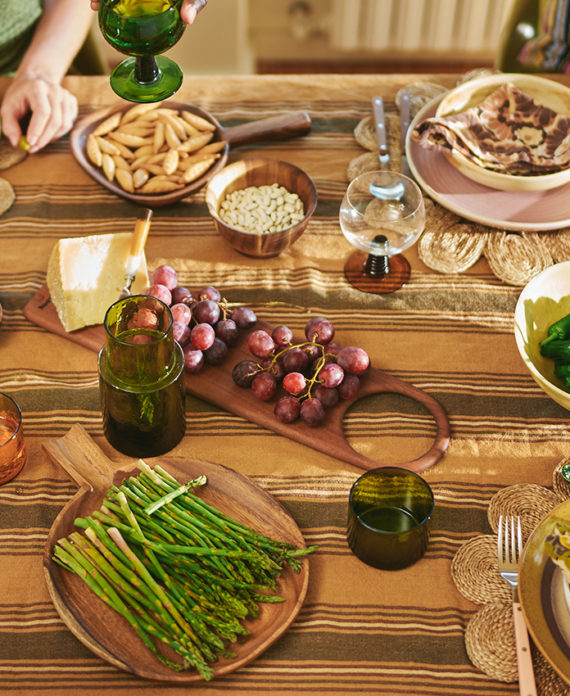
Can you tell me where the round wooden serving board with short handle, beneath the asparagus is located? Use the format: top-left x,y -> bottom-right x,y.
43,425 -> 310,683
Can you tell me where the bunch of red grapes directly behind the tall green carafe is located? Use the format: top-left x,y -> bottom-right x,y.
146,264 -> 257,372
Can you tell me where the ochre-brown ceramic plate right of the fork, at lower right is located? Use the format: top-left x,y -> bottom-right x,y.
519,500 -> 570,684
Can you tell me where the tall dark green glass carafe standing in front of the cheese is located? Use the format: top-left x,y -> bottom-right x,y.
99,295 -> 186,457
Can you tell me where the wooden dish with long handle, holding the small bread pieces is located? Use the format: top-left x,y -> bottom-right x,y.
71,101 -> 311,208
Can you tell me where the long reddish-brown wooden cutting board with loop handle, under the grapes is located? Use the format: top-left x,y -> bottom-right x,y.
24,286 -> 450,473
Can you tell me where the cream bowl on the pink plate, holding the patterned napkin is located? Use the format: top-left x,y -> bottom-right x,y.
435,73 -> 570,191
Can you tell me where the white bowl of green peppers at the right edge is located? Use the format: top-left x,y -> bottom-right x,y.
515,261 -> 570,411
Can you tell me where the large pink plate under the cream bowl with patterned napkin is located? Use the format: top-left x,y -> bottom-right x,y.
406,83 -> 570,231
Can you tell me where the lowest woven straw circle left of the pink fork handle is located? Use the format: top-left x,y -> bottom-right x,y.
465,602 -> 516,693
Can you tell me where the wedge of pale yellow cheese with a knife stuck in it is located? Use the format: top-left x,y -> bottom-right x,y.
46,232 -> 149,331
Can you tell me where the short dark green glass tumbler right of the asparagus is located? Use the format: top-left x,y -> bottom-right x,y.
347,467 -> 434,570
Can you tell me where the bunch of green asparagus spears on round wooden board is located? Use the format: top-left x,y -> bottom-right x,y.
53,460 -> 316,680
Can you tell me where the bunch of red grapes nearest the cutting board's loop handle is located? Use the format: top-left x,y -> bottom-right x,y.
232,317 -> 370,427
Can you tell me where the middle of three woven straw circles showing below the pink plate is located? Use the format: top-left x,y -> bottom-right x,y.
484,232 -> 552,286
